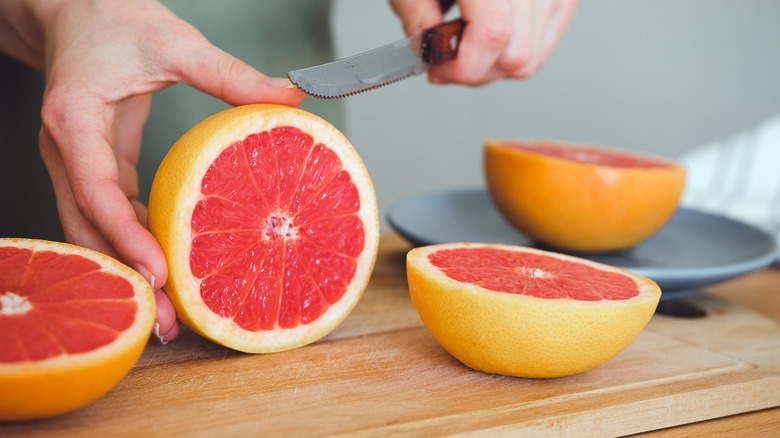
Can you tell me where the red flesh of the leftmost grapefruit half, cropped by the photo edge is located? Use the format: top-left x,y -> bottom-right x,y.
0,247 -> 137,363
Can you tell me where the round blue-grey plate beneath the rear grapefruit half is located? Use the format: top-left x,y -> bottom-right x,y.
388,189 -> 778,299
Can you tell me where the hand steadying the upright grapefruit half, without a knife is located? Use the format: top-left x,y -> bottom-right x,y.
20,0 -> 304,342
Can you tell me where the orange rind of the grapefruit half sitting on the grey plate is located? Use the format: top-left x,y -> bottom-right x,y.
484,139 -> 686,253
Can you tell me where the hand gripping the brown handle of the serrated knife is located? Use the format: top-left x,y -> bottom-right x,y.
390,0 -> 578,85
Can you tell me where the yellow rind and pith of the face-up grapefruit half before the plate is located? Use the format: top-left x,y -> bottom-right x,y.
406,243 -> 661,378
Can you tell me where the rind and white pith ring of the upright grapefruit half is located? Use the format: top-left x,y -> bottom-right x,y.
148,104 -> 379,353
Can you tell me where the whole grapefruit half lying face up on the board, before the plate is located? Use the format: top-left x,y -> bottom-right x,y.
406,243 -> 661,377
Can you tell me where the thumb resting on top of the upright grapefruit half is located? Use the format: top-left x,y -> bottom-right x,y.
167,25 -> 305,106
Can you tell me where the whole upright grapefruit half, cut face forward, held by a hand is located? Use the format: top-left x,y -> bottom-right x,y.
149,105 -> 379,353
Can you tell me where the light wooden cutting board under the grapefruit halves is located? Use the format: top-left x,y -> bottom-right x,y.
0,236 -> 780,437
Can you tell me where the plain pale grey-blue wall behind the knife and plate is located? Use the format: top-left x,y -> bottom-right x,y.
332,0 -> 780,229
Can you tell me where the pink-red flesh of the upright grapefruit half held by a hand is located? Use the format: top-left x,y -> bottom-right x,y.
190,127 -> 363,331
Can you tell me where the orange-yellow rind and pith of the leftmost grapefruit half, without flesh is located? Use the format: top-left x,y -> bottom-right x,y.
0,239 -> 156,421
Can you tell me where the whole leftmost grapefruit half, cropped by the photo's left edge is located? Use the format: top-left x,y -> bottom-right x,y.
0,239 -> 156,421
